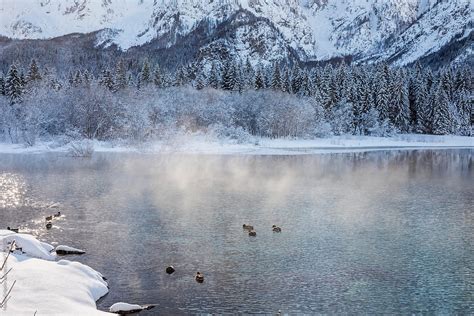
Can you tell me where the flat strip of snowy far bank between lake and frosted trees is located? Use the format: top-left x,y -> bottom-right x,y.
0,134 -> 474,155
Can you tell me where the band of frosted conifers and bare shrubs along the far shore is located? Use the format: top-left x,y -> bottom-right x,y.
0,59 -> 474,146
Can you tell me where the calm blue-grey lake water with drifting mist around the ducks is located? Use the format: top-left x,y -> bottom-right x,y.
0,150 -> 474,315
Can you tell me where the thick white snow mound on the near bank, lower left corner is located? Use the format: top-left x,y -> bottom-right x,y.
0,230 -> 108,315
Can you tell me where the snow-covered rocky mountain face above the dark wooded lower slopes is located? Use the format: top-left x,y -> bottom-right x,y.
0,0 -> 473,65
